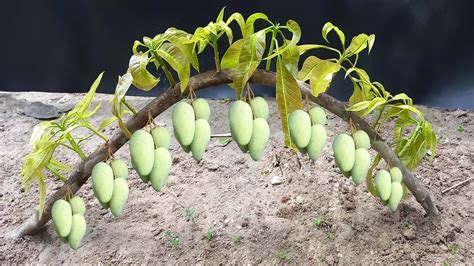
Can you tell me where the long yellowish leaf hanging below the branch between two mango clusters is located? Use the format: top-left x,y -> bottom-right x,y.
276,56 -> 303,149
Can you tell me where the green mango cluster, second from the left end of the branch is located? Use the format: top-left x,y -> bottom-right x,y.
91,159 -> 128,217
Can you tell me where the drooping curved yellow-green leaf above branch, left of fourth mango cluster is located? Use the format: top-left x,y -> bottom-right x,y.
155,43 -> 191,92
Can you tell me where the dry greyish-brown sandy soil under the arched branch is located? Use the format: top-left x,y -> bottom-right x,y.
0,93 -> 474,264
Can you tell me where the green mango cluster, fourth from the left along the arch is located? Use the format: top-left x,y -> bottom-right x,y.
172,98 -> 211,161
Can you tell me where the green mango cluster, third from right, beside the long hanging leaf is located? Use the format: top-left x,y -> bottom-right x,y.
288,106 -> 328,161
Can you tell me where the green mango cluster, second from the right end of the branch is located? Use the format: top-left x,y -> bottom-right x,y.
332,130 -> 371,185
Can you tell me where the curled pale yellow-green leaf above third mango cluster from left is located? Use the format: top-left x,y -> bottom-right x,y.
128,54 -> 160,91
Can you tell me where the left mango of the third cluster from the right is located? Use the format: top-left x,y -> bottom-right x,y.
288,110 -> 311,149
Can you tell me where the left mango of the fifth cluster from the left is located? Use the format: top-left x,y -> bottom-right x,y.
229,101 -> 253,146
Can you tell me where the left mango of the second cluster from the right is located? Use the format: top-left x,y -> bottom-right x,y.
332,133 -> 355,172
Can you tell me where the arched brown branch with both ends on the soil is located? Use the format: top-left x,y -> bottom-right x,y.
7,70 -> 440,238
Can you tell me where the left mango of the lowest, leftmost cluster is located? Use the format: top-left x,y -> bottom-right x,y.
51,199 -> 72,237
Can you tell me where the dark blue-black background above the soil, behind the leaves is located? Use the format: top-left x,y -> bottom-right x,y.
0,0 -> 474,109
